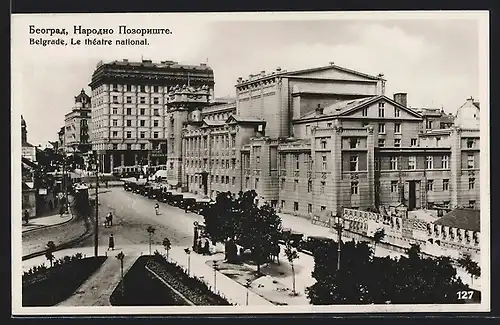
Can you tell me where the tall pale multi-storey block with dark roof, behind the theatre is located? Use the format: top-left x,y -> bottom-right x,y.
89,60 -> 214,172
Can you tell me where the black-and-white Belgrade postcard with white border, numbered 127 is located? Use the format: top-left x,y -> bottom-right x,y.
11,11 -> 490,315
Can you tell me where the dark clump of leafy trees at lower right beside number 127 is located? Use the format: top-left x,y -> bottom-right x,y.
307,238 -> 468,305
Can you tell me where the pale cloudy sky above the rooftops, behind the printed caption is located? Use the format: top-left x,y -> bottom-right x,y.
12,13 -> 488,146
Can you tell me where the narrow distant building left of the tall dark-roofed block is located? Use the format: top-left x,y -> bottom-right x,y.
61,89 -> 91,153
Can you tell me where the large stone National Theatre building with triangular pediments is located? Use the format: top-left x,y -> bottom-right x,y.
174,64 -> 479,216
